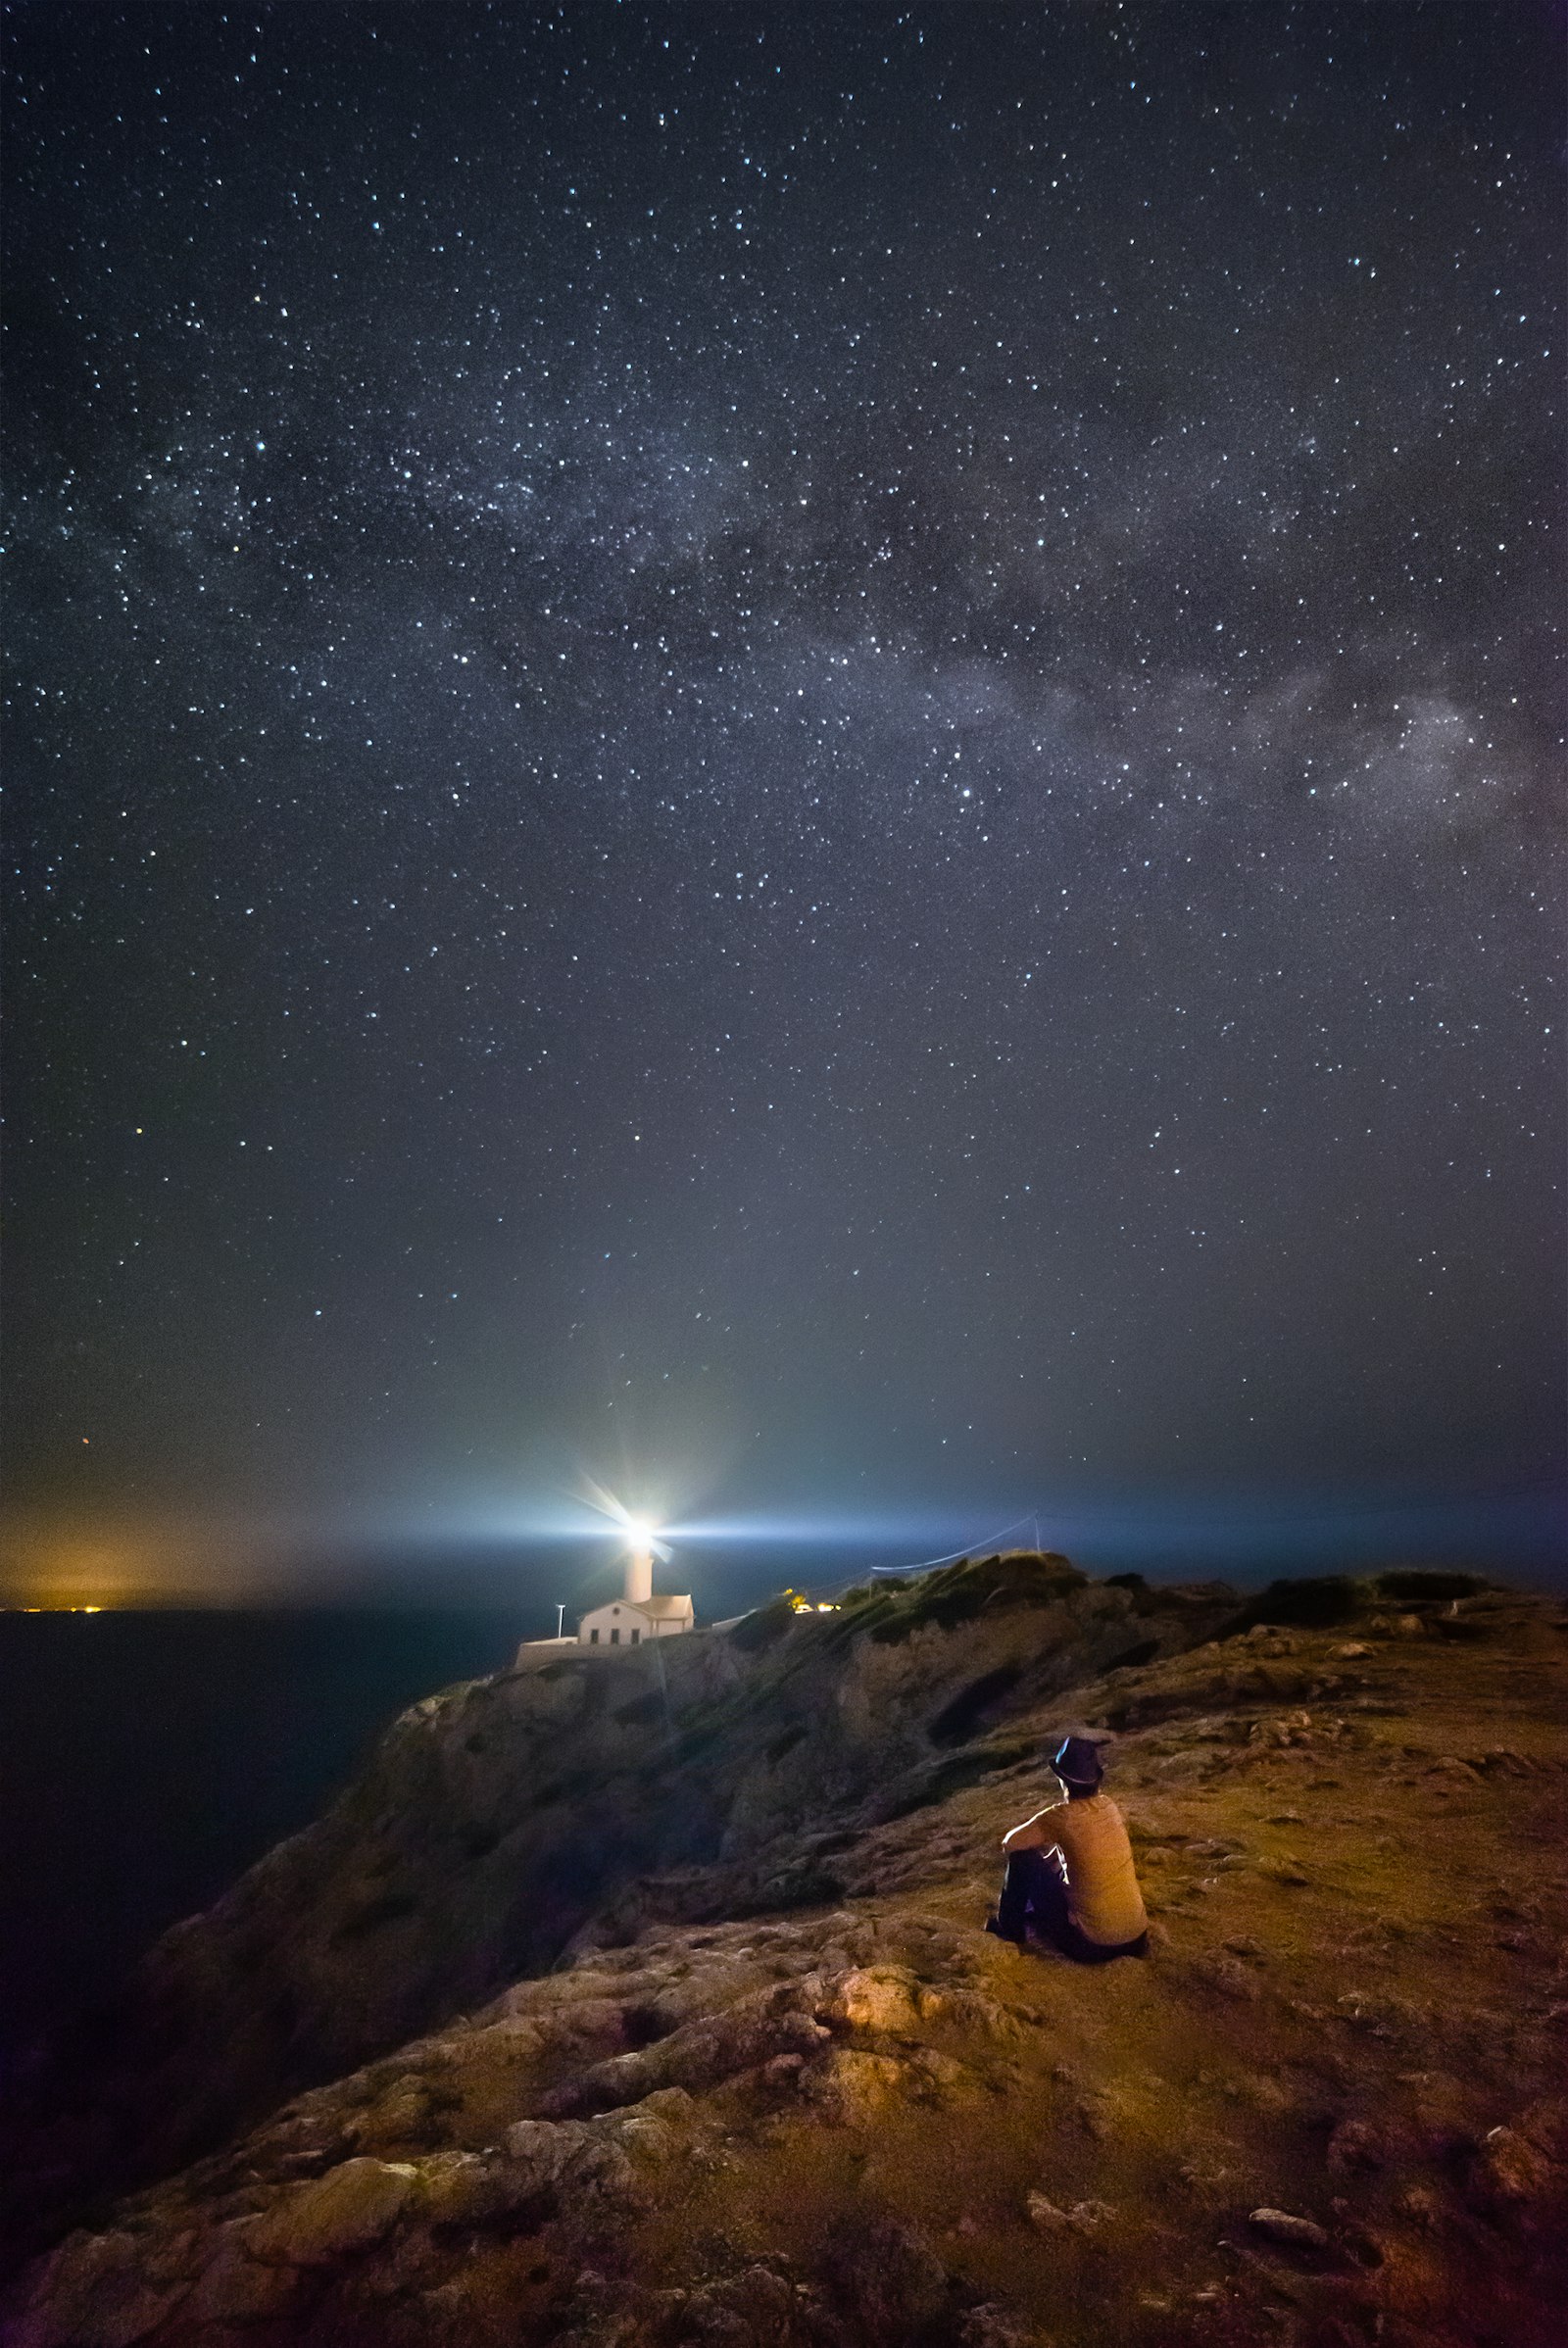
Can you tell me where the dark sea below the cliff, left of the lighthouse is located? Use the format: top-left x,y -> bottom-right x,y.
0,1569 -> 803,2080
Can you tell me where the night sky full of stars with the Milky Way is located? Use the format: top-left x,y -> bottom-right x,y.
5,0 -> 1566,1594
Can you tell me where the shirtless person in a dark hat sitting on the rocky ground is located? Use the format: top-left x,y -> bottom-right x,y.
986,1737 -> 1148,1965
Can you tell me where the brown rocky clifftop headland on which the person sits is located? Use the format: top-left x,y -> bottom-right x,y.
0,1559 -> 1568,2348
